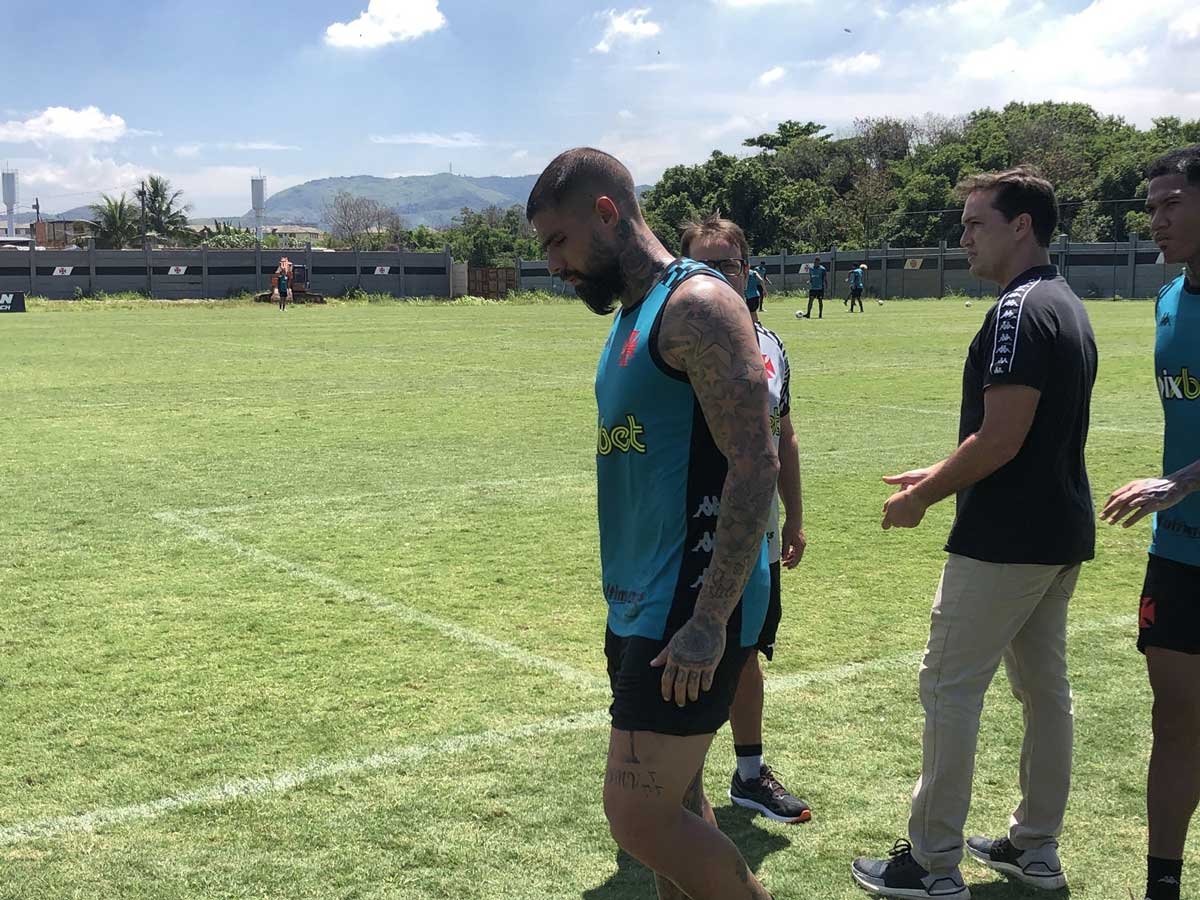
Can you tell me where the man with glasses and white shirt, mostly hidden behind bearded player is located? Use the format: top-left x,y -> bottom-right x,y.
680,215 -> 812,822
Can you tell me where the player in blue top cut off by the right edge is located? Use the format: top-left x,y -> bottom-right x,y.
1100,144 -> 1200,900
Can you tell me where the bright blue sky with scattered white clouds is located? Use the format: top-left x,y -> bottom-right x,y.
0,0 -> 1200,216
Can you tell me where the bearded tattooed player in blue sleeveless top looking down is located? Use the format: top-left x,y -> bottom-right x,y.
527,148 -> 779,900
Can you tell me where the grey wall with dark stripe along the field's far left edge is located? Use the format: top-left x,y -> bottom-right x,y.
0,247 -> 451,300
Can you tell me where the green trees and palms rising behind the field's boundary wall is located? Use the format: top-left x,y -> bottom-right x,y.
92,102 -> 1200,265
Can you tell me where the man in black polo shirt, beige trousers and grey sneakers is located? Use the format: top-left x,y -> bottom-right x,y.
852,168 -> 1096,900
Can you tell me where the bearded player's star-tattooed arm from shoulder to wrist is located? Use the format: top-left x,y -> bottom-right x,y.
660,278 -> 779,643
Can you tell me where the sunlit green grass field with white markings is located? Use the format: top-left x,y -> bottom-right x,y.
0,301 -> 1200,900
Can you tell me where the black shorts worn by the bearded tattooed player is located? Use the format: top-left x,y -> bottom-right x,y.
604,629 -> 754,737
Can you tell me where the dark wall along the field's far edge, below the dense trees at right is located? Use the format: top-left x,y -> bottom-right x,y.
517,240 -> 1183,299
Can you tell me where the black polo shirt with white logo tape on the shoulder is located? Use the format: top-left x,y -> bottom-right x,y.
946,265 -> 1096,565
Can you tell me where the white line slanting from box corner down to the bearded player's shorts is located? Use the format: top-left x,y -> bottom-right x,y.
155,512 -> 608,691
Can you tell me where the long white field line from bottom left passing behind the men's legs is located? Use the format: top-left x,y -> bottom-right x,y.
0,616 -> 1136,846
